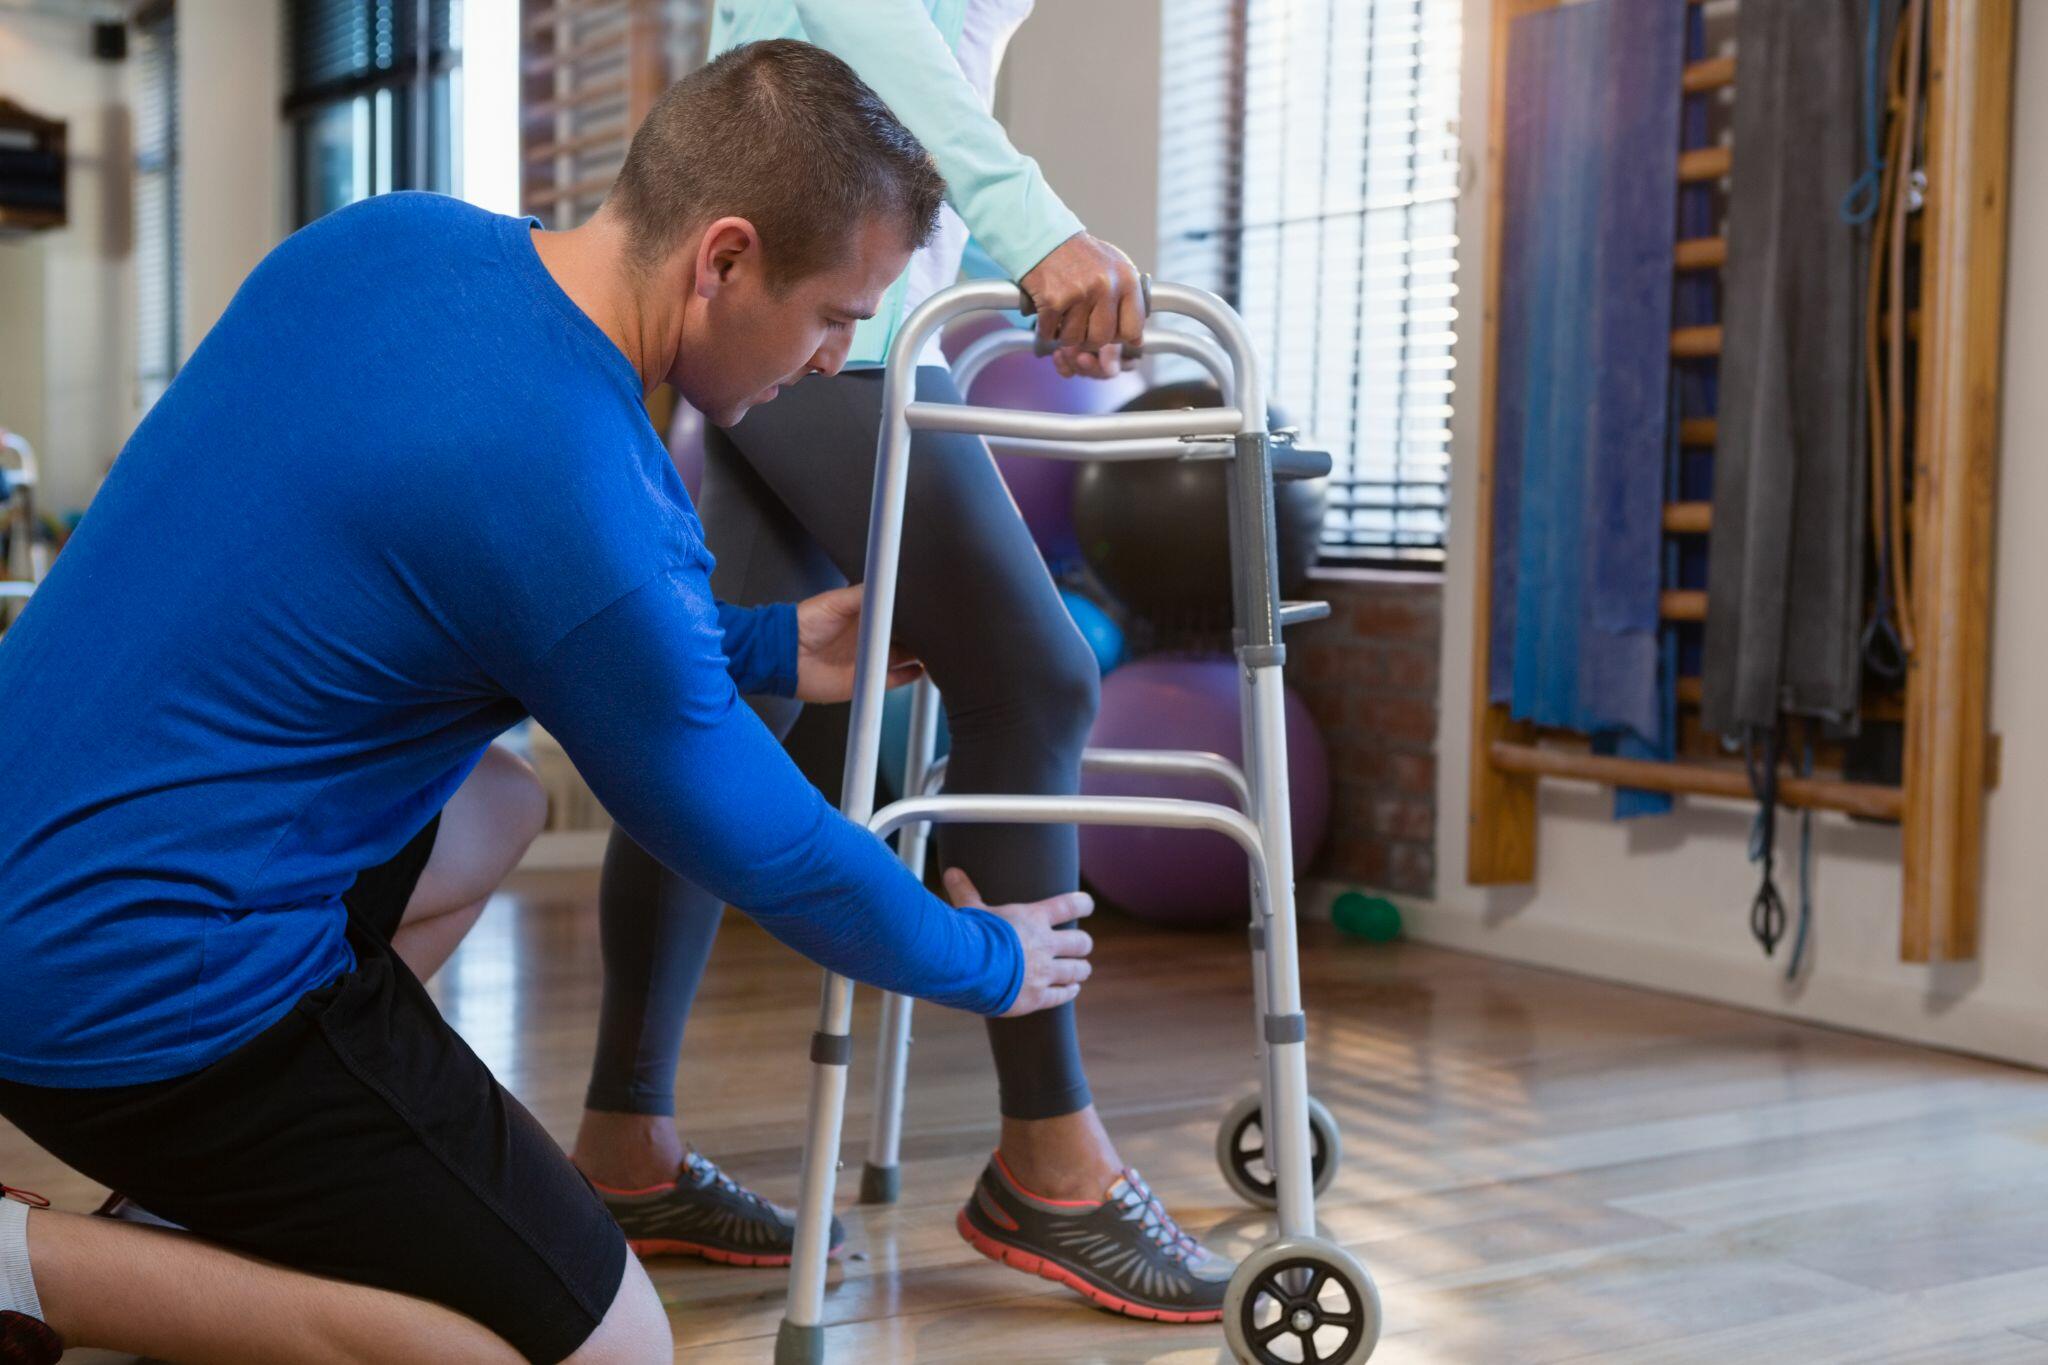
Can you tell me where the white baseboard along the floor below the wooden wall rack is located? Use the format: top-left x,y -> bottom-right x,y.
1300,882 -> 2048,1070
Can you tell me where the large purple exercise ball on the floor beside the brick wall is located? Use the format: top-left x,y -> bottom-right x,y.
1081,655 -> 1329,925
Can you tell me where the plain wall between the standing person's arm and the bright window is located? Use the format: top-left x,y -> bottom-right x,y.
995,0 -> 1159,270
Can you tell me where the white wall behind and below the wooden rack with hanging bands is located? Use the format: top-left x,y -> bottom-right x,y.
1409,0 -> 2048,1066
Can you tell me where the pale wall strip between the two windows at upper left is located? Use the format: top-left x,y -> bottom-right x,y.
178,0 -> 289,354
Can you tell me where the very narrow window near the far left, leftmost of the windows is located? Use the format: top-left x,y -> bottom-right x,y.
135,4 -> 184,411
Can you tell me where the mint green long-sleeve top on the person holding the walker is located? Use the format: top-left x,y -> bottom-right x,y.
711,0 -> 1081,364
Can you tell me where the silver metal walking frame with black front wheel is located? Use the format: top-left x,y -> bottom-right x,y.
776,280 -> 1378,1365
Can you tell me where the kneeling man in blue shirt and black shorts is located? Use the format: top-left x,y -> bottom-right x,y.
0,41 -> 1090,1365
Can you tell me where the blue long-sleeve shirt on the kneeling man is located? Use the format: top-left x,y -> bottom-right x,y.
0,194 -> 1022,1087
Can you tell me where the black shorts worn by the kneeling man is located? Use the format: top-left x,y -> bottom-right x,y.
0,823 -> 627,1361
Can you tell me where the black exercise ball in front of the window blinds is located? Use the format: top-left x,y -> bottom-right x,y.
1073,383 -> 1329,632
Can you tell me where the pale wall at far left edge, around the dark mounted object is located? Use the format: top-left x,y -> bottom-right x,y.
0,10 -> 135,512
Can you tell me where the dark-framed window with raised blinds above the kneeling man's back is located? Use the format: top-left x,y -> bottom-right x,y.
285,0 -> 457,223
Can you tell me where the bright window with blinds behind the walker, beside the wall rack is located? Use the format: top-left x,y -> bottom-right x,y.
1159,0 -> 1462,563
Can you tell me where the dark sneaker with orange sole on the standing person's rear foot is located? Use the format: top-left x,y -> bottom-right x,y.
596,1148 -> 846,1265
